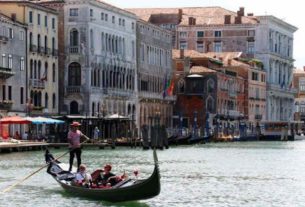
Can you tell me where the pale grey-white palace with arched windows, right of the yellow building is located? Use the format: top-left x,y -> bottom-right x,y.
64,0 -> 138,118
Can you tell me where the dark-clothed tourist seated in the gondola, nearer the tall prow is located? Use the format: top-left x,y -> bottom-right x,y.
92,164 -> 126,187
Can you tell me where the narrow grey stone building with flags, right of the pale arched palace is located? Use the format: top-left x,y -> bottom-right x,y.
137,20 -> 175,132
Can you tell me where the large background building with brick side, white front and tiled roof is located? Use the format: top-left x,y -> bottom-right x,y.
129,7 -> 297,121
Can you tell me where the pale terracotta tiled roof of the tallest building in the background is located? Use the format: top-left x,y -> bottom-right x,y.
126,7 -> 259,25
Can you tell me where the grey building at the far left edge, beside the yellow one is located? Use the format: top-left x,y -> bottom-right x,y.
0,14 -> 27,117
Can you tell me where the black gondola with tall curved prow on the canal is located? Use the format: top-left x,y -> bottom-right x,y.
47,150 -> 161,202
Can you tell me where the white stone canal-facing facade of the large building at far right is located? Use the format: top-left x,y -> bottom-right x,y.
255,16 -> 297,121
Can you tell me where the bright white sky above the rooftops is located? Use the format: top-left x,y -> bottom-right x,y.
104,0 -> 305,68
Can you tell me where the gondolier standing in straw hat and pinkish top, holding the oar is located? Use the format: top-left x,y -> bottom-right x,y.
68,121 -> 88,171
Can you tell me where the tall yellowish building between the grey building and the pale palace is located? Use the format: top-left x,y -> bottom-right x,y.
0,1 -> 58,114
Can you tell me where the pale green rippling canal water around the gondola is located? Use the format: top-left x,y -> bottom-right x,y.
0,141 -> 305,207
